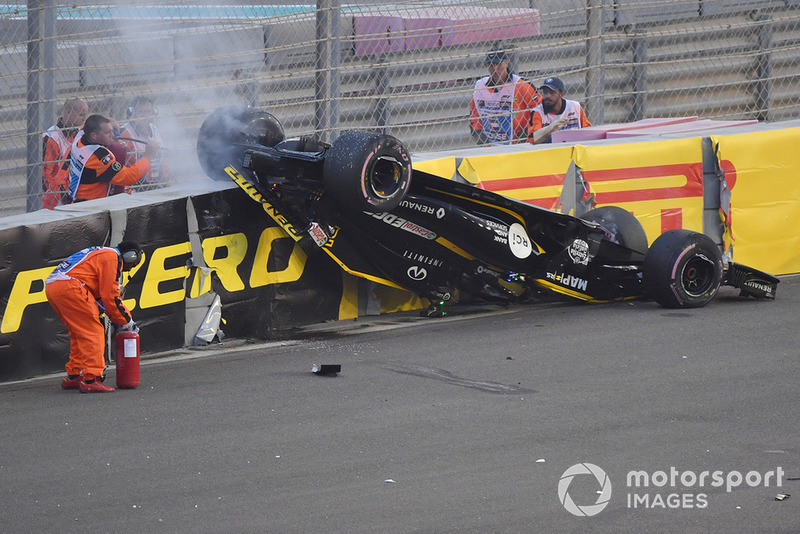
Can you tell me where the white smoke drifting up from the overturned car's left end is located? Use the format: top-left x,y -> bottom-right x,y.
82,3 -> 313,184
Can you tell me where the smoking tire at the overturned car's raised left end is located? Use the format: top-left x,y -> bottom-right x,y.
197,106 -> 285,180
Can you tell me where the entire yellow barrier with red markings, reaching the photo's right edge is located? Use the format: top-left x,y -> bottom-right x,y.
414,132 -> 800,274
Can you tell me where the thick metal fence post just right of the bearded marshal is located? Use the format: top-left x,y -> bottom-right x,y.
586,0 -> 605,124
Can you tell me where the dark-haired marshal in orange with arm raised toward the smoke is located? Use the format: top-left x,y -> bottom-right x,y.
69,115 -> 161,202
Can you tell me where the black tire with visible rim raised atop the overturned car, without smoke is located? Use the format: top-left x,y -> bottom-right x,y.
322,130 -> 411,212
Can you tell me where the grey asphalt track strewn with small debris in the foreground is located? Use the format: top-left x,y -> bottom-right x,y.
0,277 -> 800,534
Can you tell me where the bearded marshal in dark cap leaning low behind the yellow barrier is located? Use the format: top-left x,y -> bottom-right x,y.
528,77 -> 592,145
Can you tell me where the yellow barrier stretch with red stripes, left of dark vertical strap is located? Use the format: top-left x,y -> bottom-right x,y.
422,138 -> 703,242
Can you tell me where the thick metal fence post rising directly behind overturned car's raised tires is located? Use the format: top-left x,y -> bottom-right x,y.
314,0 -> 341,142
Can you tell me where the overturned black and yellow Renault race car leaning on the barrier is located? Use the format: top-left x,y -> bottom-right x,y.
197,106 -> 778,316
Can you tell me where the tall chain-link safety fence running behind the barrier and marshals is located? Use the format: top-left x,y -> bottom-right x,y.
0,0 -> 800,216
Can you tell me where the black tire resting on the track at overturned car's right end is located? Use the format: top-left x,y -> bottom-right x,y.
642,230 -> 723,308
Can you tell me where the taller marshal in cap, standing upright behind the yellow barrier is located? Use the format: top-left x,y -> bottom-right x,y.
470,46 -> 541,145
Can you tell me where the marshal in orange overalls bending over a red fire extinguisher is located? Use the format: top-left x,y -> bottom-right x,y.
45,241 -> 143,393
